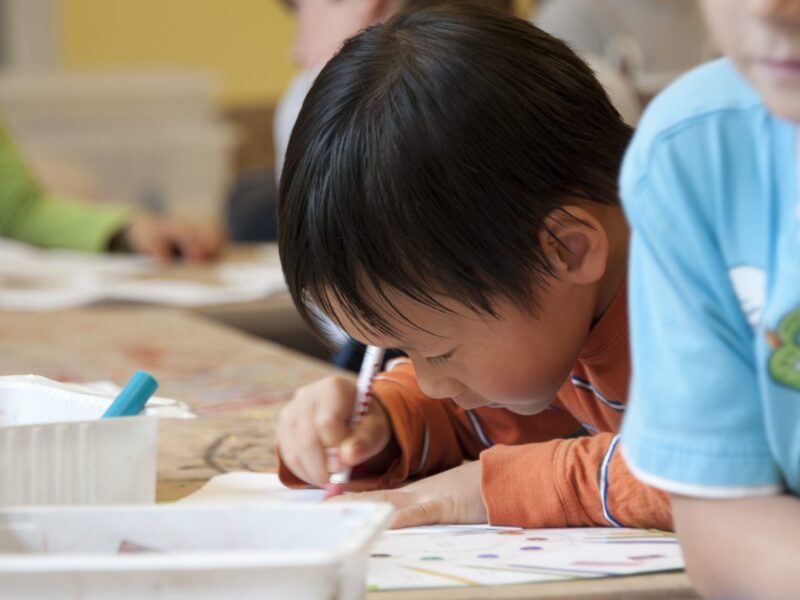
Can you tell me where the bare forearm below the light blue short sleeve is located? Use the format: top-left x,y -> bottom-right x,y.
670,495 -> 800,598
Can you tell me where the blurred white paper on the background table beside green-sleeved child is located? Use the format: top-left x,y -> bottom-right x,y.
0,240 -> 286,310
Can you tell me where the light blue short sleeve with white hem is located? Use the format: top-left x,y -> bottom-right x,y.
621,128 -> 780,497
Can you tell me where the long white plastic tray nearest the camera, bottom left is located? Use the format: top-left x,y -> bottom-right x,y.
0,503 -> 392,600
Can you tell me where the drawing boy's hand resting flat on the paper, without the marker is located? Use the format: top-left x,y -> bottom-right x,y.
331,460 -> 487,529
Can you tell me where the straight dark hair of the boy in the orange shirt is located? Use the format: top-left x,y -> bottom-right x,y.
278,5 -> 630,334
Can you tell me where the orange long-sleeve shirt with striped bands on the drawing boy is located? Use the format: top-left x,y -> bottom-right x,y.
280,286 -> 672,529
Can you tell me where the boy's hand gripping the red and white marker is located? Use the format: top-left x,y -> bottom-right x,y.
276,376 -> 393,487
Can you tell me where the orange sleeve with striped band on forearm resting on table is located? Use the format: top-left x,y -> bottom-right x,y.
481,433 -> 672,530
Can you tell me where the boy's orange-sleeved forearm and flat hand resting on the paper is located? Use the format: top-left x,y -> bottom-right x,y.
336,433 -> 672,529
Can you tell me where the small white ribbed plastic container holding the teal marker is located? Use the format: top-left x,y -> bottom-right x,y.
0,375 -> 158,506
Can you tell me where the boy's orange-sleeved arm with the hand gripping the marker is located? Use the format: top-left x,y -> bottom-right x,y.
277,362 -> 582,489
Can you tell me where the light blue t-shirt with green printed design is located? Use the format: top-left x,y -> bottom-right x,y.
620,59 -> 800,497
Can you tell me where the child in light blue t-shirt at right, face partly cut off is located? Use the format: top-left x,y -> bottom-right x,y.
621,0 -> 800,599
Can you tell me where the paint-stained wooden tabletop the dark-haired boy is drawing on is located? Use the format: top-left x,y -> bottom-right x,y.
0,307 -> 696,600
